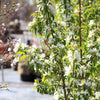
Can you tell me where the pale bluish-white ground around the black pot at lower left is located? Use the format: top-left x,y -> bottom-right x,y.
0,69 -> 53,100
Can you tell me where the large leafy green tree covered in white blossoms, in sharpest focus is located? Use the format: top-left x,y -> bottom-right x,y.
16,0 -> 100,100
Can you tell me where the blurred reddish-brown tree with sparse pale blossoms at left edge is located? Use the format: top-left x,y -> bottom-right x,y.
0,0 -> 20,88
